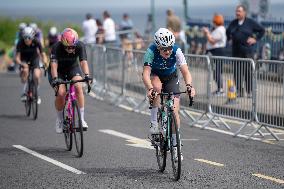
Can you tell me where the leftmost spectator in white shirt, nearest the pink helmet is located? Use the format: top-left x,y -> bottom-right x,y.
82,13 -> 98,44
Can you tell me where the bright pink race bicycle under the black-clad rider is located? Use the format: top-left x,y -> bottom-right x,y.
55,78 -> 92,157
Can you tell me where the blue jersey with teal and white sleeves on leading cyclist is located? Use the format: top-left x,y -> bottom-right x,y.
144,43 -> 186,76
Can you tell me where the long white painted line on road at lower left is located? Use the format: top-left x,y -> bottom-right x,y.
13,145 -> 86,175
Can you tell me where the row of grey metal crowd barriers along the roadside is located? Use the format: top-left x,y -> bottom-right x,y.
85,46 -> 284,140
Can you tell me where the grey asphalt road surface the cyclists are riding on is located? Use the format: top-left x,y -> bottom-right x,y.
0,71 -> 284,189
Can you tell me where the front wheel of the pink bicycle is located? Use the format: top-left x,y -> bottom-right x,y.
72,100 -> 84,157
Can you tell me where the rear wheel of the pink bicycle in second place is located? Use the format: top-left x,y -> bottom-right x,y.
63,101 -> 73,151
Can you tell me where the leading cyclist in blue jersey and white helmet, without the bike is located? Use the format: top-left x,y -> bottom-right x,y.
143,28 -> 195,160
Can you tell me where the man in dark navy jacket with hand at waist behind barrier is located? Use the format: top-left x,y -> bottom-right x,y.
226,5 -> 265,97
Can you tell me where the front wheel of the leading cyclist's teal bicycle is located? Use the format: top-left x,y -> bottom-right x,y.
168,113 -> 181,181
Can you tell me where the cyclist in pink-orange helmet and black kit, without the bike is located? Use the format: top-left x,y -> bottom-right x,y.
48,28 -> 89,133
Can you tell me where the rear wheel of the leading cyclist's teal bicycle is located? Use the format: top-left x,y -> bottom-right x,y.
155,108 -> 167,172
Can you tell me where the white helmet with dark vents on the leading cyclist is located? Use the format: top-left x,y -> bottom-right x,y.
154,28 -> 175,47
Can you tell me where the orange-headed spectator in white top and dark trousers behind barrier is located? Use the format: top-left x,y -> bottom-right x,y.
202,14 -> 227,96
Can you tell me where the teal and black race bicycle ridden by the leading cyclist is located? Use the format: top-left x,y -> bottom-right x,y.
149,91 -> 193,181
